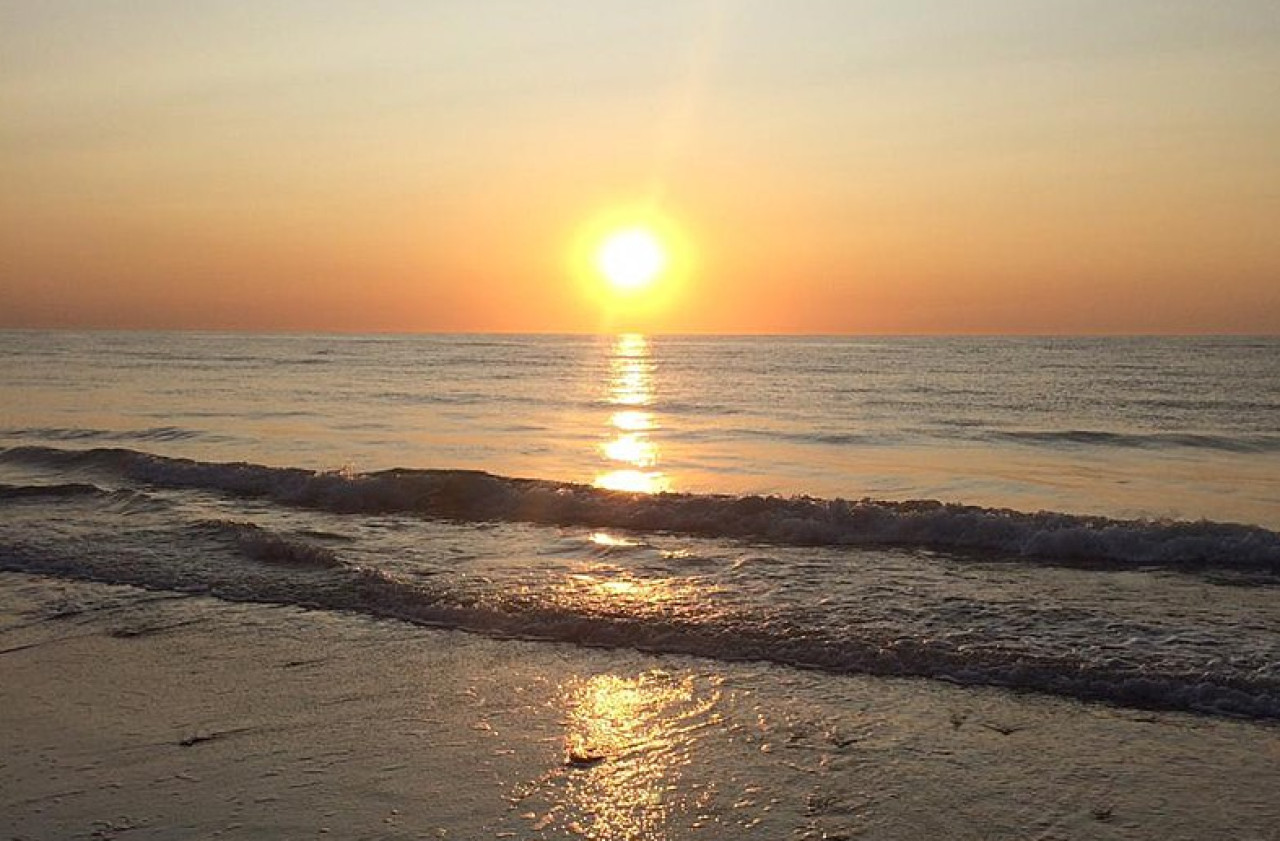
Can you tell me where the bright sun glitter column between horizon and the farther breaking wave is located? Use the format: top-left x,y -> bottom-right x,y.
595,333 -> 671,494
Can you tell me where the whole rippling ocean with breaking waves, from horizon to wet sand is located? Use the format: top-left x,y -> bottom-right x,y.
0,332 -> 1280,719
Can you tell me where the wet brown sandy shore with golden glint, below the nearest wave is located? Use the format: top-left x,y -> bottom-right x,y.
0,573 -> 1280,841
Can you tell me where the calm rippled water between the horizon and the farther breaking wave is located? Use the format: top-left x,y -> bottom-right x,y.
0,332 -> 1280,527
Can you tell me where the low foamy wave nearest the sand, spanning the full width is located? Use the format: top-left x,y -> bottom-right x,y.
0,532 -> 1280,719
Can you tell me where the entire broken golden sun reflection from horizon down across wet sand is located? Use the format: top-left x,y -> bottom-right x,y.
526,333 -> 719,841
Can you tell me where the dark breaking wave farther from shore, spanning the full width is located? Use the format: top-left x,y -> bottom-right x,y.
0,447 -> 1280,573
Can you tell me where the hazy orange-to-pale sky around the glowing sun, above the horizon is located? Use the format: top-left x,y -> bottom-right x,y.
0,0 -> 1280,334
